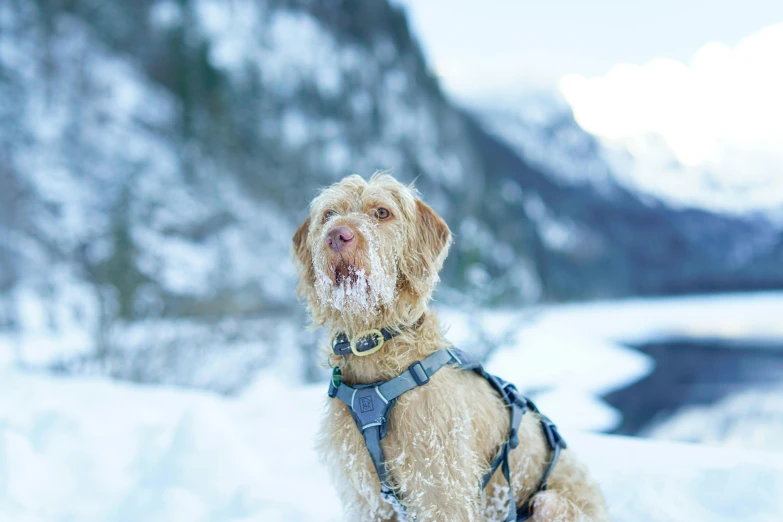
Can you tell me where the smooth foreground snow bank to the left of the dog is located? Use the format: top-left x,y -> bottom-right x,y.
0,366 -> 338,522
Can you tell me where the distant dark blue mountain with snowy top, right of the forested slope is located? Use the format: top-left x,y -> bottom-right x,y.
469,94 -> 783,299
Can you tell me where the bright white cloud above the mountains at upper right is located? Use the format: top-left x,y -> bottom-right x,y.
560,24 -> 783,209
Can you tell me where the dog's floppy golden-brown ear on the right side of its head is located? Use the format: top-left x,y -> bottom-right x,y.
400,200 -> 451,299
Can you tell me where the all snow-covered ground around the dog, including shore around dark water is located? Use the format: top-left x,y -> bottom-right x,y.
0,293 -> 783,522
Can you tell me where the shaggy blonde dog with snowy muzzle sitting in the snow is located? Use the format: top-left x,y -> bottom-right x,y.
293,174 -> 608,522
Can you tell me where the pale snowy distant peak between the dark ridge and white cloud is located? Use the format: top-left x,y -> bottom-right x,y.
474,90 -> 783,219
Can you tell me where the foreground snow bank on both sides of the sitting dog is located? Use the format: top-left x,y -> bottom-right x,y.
0,371 -> 783,522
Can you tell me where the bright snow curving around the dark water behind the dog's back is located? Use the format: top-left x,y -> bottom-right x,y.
472,292 -> 783,431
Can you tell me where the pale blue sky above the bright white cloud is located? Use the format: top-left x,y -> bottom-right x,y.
395,0 -> 783,96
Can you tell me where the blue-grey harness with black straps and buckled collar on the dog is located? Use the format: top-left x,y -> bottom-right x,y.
329,329 -> 566,522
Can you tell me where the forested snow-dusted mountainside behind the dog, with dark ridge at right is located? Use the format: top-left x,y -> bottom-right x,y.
0,0 -> 783,392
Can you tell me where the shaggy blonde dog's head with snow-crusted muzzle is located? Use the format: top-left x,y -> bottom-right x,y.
293,174 -> 451,330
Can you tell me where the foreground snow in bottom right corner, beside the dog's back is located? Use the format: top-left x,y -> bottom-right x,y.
568,435 -> 783,522
